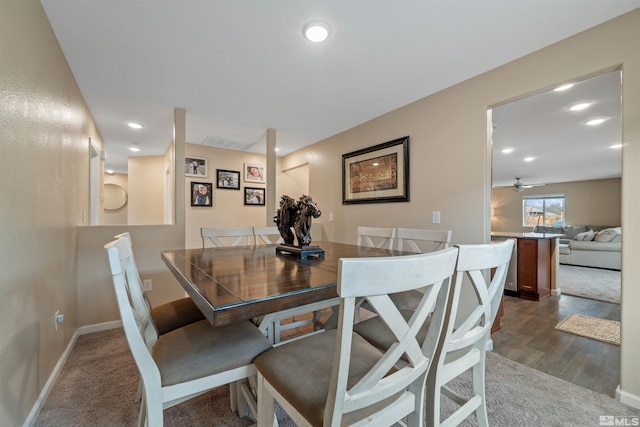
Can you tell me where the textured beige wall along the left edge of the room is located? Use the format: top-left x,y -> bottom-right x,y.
0,0 -> 102,426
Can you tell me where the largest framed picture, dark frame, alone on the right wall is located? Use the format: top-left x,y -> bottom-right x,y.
342,136 -> 409,205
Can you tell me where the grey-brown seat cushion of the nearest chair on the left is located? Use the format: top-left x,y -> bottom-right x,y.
152,320 -> 271,386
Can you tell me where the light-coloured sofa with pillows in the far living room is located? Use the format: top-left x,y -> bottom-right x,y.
534,225 -> 622,270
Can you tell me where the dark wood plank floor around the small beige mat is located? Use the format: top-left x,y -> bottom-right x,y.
492,295 -> 620,397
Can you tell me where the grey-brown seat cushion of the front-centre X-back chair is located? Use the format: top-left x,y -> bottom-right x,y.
254,330 -> 399,426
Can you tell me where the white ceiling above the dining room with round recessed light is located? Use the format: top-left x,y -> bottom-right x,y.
41,0 -> 640,180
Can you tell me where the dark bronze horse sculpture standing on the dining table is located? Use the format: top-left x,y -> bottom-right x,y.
273,195 -> 322,248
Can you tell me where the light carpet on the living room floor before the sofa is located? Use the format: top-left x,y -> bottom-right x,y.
557,264 -> 620,304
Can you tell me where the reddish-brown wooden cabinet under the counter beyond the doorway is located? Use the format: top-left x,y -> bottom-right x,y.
518,238 -> 551,300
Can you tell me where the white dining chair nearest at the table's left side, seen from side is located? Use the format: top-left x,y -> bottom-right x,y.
105,239 -> 271,426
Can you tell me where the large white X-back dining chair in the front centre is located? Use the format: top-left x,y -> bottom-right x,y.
254,248 -> 457,427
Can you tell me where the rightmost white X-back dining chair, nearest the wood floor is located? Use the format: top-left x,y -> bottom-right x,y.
426,240 -> 513,427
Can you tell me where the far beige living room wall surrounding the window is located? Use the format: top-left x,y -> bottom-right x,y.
491,178 -> 622,232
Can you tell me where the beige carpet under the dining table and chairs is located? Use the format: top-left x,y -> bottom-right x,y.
33,329 -> 640,427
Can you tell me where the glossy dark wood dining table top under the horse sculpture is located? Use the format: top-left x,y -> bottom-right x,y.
162,242 -> 407,326
